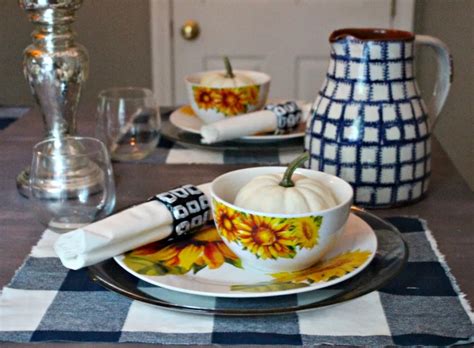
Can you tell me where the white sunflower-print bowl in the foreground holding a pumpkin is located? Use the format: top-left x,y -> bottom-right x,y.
211,167 -> 353,272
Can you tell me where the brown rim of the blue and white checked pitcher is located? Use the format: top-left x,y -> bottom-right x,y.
329,28 -> 415,42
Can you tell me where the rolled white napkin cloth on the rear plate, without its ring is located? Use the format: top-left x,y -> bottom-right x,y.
201,103 -> 311,144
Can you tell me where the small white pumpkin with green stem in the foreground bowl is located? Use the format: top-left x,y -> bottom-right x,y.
234,152 -> 338,214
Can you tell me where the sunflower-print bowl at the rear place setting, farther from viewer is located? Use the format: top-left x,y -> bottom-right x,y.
185,70 -> 270,124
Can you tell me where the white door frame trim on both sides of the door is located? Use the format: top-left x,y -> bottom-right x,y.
149,0 -> 415,106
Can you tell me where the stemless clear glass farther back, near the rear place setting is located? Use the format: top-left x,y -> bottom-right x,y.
96,87 -> 161,161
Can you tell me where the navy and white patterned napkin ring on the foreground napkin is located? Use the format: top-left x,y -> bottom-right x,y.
151,185 -> 210,237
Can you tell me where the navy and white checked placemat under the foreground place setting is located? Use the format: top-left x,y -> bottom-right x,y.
0,217 -> 474,346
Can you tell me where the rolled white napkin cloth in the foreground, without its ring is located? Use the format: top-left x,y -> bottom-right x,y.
54,184 -> 211,270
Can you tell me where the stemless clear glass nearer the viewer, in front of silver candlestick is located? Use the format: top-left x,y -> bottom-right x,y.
30,136 -> 115,232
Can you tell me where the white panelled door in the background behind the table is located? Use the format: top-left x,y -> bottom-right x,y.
151,0 -> 413,104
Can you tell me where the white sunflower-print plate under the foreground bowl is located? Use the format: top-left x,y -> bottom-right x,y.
115,214 -> 377,298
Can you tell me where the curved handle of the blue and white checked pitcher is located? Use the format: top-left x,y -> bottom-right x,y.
415,35 -> 453,127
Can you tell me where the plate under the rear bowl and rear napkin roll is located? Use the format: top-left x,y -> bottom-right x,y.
170,105 -> 306,143
